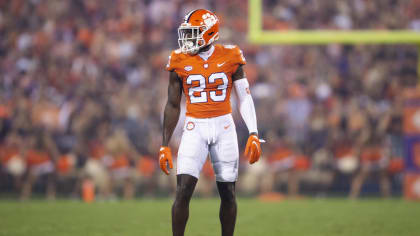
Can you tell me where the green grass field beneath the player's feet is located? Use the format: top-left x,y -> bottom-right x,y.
0,199 -> 420,236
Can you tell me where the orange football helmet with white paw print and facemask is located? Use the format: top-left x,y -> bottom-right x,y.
178,9 -> 219,54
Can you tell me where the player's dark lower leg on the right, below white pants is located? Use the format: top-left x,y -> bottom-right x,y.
217,182 -> 237,236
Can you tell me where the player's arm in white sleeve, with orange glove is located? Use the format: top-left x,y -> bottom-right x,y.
232,65 -> 261,164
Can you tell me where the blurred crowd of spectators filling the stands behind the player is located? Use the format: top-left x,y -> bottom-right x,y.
0,0 -> 420,199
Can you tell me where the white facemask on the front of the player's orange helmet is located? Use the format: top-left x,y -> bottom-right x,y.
178,24 -> 207,54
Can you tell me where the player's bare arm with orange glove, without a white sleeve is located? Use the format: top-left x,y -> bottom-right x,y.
159,71 -> 182,175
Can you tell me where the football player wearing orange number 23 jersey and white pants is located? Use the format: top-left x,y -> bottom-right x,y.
159,9 -> 261,236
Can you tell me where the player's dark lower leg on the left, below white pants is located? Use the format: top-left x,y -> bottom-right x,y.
172,174 -> 198,236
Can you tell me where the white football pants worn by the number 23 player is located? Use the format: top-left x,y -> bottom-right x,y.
177,114 -> 239,182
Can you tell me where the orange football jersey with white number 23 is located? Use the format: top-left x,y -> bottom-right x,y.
166,44 -> 246,118
